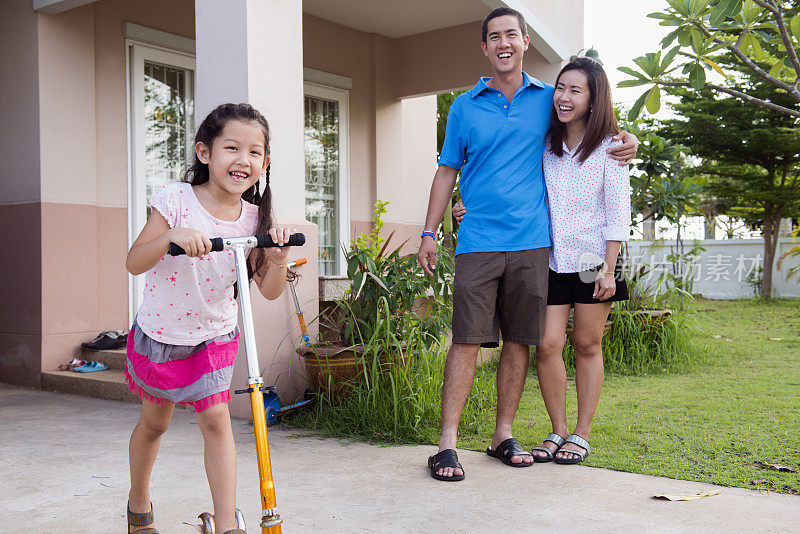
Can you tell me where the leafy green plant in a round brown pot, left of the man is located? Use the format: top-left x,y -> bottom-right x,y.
297,201 -> 453,394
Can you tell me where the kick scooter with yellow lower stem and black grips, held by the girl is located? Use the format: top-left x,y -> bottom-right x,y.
169,234 -> 306,534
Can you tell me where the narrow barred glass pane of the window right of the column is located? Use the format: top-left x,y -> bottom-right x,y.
305,96 -> 340,275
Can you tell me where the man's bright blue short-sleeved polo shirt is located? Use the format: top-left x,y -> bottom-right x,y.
439,72 -> 554,254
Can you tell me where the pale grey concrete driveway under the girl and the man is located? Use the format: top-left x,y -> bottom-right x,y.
0,384 -> 800,534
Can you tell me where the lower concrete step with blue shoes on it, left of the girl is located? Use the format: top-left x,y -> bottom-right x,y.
42,370 -> 139,403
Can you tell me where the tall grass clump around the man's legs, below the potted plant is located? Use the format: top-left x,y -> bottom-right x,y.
288,300 -> 497,443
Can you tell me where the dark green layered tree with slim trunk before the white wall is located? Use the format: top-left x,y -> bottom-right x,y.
660,55 -> 800,299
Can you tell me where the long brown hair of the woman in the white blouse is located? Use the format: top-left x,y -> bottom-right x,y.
550,57 -> 619,163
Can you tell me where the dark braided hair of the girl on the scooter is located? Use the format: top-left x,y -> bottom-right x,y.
183,104 -> 272,284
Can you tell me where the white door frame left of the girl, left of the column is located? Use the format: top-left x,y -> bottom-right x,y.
124,31 -> 197,323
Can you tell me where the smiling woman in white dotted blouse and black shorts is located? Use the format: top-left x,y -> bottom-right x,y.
453,58 -> 631,464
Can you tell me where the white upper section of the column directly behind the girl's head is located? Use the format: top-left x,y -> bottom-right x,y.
195,0 -> 305,218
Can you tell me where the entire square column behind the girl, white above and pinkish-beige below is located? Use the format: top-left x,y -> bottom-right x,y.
195,0 -> 318,418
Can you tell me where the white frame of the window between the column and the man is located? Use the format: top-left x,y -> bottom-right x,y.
303,81 -> 350,278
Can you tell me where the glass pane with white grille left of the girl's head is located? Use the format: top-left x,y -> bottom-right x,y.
144,61 -> 194,217
